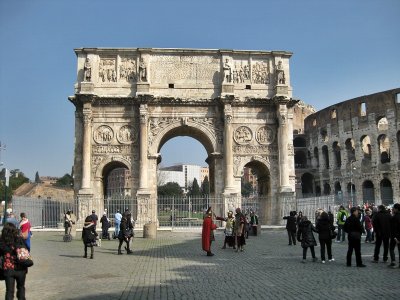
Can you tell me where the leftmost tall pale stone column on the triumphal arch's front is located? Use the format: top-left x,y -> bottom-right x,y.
81,103 -> 92,190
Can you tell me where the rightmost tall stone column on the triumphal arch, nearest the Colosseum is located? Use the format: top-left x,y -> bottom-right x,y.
277,100 -> 291,192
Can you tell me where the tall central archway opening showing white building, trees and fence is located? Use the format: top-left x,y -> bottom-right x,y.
156,131 -> 215,227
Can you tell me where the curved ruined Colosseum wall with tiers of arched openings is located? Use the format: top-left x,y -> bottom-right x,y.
293,88 -> 400,205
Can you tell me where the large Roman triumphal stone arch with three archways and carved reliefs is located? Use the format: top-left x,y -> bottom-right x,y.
69,48 -> 297,224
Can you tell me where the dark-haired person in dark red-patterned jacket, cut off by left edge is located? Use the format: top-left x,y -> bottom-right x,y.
0,223 -> 27,299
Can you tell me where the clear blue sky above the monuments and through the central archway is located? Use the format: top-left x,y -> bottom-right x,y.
0,0 -> 400,179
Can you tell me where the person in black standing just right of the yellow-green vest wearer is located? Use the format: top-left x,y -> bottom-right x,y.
343,207 -> 366,267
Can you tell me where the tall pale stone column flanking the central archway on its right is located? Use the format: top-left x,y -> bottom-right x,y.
224,104 -> 233,191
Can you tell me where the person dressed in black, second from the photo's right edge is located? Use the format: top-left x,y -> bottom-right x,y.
372,205 -> 390,263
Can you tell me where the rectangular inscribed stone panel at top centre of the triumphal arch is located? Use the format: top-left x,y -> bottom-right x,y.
150,55 -> 220,83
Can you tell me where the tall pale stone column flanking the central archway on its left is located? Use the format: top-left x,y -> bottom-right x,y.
139,104 -> 148,190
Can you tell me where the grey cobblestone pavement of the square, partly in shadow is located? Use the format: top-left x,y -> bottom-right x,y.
0,230 -> 400,300
